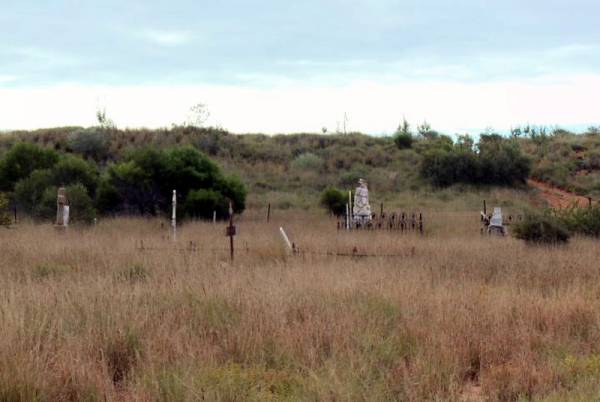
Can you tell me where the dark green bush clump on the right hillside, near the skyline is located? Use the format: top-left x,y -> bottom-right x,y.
420,134 -> 532,187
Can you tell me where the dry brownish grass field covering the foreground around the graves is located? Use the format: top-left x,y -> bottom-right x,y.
0,212 -> 600,401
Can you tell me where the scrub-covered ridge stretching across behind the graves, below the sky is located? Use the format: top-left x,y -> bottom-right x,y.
0,122 -> 600,208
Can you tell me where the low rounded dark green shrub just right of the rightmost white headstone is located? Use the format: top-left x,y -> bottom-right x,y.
512,213 -> 570,244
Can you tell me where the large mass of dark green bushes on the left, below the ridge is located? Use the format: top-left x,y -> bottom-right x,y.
0,141 -> 246,222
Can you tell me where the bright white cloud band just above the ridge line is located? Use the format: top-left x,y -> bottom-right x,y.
0,74 -> 600,133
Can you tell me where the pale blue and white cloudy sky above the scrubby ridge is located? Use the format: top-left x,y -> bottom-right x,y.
0,0 -> 600,134
